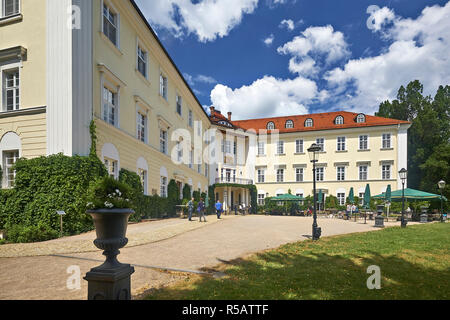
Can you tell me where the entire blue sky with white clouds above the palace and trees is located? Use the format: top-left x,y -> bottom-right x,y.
137,0 -> 450,119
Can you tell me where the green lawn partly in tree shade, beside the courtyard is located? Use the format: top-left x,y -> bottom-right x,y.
147,223 -> 450,300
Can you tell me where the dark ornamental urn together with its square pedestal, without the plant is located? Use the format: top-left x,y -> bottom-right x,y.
84,209 -> 134,300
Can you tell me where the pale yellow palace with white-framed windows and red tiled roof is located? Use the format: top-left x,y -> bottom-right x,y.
0,0 -> 410,208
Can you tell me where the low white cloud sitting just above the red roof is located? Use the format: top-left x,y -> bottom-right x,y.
211,76 -> 320,120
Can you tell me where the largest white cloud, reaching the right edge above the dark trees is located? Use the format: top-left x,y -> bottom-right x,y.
325,2 -> 450,113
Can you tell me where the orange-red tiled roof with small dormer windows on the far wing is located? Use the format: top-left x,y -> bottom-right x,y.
232,111 -> 410,133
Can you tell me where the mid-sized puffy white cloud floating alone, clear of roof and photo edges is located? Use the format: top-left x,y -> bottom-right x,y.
278,25 -> 350,76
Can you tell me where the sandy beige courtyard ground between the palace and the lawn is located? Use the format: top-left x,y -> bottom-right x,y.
0,215 -> 418,300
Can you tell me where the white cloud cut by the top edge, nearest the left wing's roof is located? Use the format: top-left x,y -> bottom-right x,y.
138,0 -> 258,42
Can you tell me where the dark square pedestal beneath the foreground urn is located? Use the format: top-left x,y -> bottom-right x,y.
84,264 -> 134,300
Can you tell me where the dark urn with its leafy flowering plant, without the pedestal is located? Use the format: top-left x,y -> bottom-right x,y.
87,176 -> 134,270
